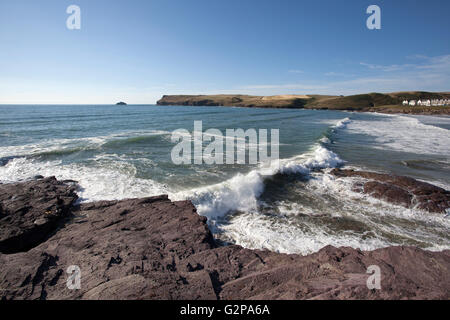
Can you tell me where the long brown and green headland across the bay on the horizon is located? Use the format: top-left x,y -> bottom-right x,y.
157,91 -> 450,114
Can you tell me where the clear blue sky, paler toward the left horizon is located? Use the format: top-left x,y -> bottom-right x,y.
0,0 -> 450,104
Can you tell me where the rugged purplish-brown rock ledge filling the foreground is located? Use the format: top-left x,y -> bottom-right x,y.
0,177 -> 450,299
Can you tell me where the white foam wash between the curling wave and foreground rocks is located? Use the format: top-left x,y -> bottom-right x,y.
216,173 -> 450,254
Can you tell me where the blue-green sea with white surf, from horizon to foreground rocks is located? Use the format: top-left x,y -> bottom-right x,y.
0,105 -> 450,254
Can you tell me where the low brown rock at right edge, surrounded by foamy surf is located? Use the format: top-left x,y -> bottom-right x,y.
331,169 -> 450,213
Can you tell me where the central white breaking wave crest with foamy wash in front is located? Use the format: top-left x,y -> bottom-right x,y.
173,114 -> 450,254
